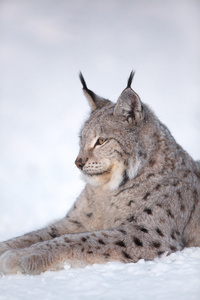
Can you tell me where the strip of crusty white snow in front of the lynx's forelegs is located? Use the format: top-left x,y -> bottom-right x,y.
0,248 -> 200,300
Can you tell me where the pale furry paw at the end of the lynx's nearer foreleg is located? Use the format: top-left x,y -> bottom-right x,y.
0,250 -> 44,275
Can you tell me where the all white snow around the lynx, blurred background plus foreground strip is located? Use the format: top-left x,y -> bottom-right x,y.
0,0 -> 200,300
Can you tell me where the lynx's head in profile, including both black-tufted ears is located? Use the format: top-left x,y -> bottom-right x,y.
75,72 -> 150,189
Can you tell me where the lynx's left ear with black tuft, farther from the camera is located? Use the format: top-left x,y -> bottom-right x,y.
79,72 -> 111,111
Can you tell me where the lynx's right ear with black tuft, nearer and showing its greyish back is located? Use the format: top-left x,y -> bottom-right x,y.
114,71 -> 143,125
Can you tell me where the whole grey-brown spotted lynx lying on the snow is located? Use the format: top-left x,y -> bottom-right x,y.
0,72 -> 200,274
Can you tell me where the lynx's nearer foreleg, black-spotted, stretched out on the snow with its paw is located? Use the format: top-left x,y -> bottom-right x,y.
0,229 -> 181,274
